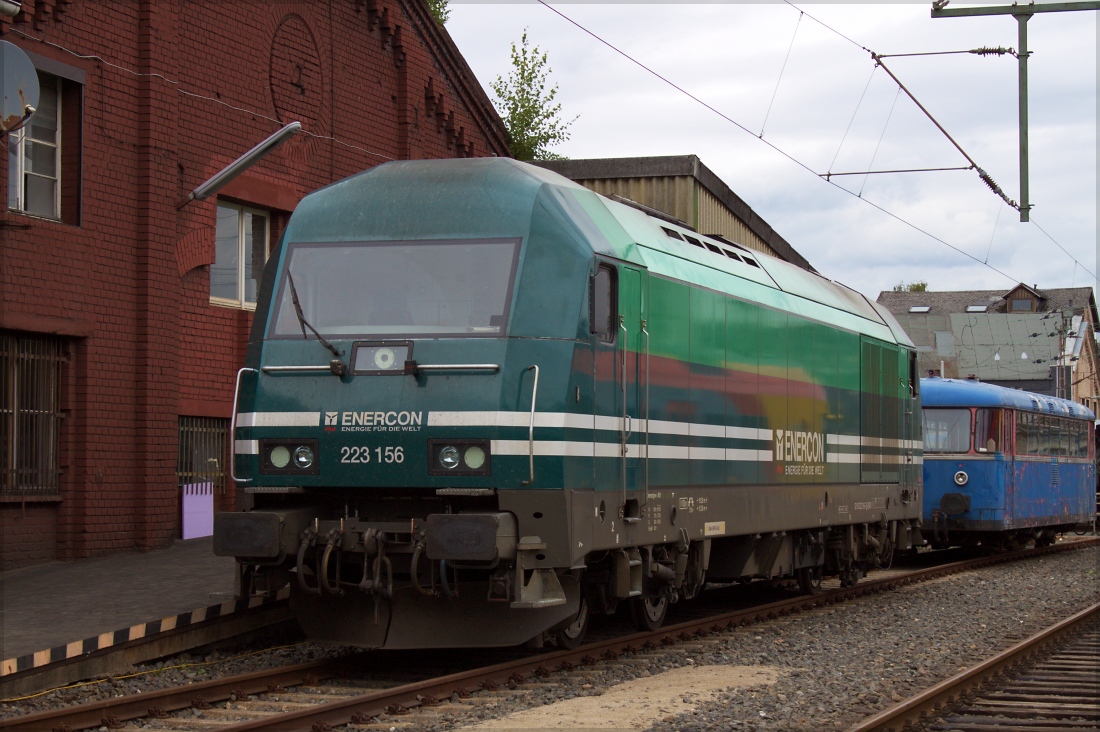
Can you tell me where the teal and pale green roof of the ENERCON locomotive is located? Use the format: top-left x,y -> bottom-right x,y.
272,157 -> 912,348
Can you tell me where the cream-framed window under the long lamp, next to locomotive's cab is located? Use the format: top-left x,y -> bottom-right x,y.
210,203 -> 271,309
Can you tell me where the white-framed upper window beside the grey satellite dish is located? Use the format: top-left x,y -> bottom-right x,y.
8,72 -> 62,219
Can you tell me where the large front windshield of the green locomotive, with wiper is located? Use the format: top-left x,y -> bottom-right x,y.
267,240 -> 519,338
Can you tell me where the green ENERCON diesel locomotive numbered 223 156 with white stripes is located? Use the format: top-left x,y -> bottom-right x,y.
215,159 -> 921,648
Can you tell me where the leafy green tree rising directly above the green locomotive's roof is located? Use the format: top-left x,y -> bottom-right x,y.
492,29 -> 576,160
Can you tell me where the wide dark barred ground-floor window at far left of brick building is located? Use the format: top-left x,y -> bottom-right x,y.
0,332 -> 65,498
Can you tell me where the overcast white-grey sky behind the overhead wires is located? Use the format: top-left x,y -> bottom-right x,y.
447,0 -> 1100,297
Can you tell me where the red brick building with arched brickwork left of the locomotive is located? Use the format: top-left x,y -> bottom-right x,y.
0,0 -> 507,568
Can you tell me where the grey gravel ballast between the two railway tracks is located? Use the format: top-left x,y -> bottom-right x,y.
444,547 -> 1100,732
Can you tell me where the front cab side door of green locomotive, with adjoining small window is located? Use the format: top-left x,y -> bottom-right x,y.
589,261 -> 649,522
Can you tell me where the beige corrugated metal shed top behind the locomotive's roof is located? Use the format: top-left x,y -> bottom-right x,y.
535,155 -> 815,272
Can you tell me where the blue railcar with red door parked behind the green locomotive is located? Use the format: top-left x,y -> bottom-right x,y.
921,379 -> 1097,548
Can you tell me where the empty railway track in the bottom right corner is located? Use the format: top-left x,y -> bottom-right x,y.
848,603 -> 1100,732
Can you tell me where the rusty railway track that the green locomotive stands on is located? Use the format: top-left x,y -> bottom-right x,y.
0,539 -> 1100,732
